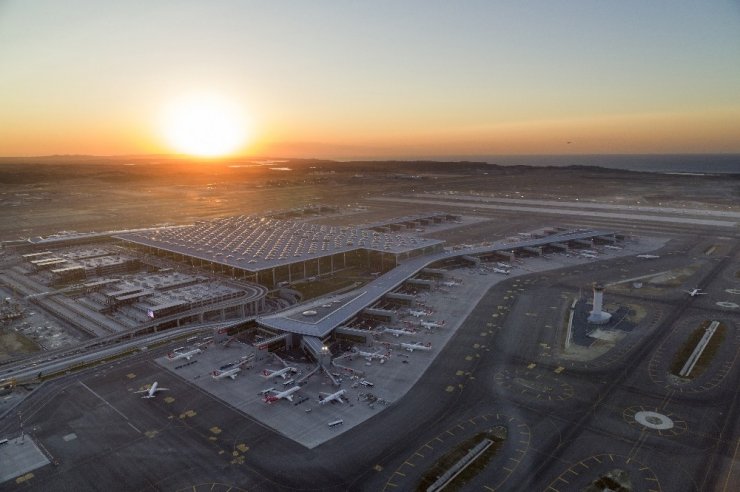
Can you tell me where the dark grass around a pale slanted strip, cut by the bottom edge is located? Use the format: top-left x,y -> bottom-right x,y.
416,426 -> 508,492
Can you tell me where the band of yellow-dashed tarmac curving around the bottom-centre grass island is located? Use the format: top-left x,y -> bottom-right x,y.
378,413 -> 531,490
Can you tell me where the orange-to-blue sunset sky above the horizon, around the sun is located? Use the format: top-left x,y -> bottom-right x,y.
0,0 -> 740,158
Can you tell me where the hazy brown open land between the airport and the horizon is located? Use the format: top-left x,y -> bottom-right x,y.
0,157 -> 740,240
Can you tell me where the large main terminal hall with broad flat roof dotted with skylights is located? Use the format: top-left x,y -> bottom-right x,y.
114,214 -> 446,287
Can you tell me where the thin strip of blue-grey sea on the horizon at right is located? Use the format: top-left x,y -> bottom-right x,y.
388,154 -> 740,174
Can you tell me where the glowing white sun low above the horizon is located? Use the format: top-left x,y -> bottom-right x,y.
163,94 -> 248,157
